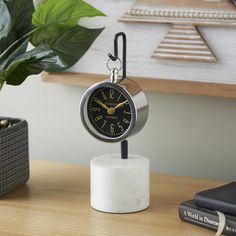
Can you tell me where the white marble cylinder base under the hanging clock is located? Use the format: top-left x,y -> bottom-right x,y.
90,154 -> 150,213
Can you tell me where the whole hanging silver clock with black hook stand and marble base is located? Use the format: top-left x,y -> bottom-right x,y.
80,32 -> 150,213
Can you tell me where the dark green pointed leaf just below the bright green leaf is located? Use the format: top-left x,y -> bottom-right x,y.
45,25 -> 103,72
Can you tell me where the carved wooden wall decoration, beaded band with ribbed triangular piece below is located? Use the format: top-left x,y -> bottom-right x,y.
120,0 -> 236,63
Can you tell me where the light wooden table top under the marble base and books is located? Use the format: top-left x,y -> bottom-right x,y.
0,160 -> 223,236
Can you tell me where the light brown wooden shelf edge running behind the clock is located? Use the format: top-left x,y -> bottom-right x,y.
42,72 -> 236,98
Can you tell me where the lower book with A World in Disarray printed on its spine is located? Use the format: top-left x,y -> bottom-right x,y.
179,200 -> 236,236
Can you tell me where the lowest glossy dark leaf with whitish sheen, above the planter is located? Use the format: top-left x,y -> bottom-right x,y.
0,44 -> 68,85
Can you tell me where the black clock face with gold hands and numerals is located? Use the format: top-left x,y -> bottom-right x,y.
87,87 -> 132,138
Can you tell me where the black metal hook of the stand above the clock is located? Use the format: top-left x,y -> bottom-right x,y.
108,32 -> 127,79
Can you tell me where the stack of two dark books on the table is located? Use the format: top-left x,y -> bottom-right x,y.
179,182 -> 236,236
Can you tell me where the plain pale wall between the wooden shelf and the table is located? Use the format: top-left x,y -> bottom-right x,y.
0,76 -> 236,180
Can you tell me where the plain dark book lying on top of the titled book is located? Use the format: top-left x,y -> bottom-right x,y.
194,182 -> 236,216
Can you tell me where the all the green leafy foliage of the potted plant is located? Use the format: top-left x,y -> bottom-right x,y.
0,0 -> 104,89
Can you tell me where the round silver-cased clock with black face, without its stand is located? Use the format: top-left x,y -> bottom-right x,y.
80,79 -> 148,142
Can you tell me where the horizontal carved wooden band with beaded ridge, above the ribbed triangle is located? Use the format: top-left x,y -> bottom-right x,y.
121,0 -> 236,27
